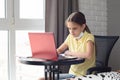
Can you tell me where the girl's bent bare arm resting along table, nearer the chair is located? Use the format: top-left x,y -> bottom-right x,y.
65,41 -> 94,59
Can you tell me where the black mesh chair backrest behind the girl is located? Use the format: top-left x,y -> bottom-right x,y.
95,35 -> 119,66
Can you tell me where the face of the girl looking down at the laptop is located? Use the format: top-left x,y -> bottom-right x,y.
67,22 -> 85,37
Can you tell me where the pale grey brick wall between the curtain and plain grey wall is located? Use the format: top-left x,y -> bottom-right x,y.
79,0 -> 107,35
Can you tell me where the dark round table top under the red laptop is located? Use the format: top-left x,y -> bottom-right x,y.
18,57 -> 85,65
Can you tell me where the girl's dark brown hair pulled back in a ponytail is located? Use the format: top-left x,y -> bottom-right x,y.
66,12 -> 90,33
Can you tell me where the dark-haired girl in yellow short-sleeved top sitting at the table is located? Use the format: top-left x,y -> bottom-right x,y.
40,12 -> 95,80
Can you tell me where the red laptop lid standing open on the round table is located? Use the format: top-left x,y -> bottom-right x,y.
28,32 -> 58,60
